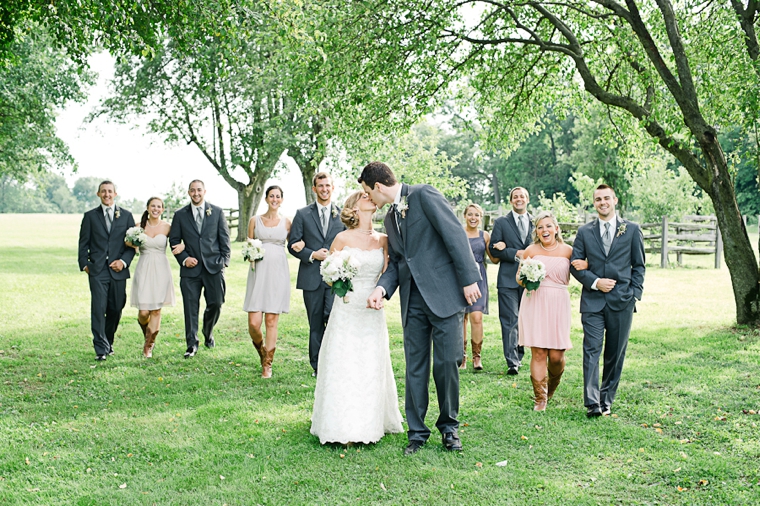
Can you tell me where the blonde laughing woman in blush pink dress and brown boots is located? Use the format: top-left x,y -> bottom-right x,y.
517,211 -> 588,411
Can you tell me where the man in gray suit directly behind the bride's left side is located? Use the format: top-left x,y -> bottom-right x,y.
288,172 -> 346,376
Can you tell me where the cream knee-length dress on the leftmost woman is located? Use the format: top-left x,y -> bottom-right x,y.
130,234 -> 175,310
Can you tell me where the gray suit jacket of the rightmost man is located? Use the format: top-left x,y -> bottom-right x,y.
570,219 -> 646,313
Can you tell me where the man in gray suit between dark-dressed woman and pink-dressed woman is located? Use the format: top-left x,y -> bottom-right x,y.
490,186 -> 533,375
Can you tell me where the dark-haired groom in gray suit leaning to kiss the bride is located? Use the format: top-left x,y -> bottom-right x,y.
359,162 -> 480,455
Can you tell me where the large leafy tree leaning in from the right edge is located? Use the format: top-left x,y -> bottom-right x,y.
314,0 -> 760,323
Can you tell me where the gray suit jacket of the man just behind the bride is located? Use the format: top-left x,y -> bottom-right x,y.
288,202 -> 346,291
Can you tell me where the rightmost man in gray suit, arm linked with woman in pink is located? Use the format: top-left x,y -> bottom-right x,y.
571,184 -> 646,418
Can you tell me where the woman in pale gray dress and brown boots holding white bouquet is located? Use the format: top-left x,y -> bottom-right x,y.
243,186 -> 290,378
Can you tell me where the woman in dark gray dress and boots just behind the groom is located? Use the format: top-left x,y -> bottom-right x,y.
459,204 -> 499,371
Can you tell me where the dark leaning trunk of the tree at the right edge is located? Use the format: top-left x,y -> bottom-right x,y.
700,134 -> 760,325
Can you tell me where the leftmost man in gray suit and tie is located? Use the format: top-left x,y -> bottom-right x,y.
79,181 -> 135,360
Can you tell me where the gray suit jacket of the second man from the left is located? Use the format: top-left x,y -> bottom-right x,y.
169,202 -> 231,278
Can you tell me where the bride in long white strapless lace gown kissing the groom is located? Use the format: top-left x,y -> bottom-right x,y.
311,191 -> 403,444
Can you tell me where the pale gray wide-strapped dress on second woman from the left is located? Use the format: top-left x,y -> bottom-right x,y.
243,216 -> 290,314
